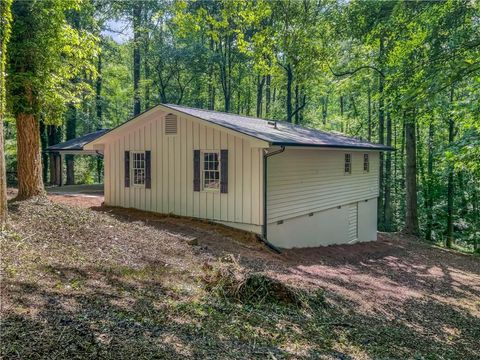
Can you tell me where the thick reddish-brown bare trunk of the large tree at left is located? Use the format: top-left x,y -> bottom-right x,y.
16,113 -> 45,200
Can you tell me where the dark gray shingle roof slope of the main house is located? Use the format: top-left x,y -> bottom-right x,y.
163,104 -> 393,150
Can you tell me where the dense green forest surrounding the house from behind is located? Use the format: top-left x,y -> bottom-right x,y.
0,0 -> 480,251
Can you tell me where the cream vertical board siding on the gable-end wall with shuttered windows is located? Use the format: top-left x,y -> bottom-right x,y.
105,112 -> 263,225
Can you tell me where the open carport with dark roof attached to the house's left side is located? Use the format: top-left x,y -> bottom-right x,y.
45,129 -> 108,186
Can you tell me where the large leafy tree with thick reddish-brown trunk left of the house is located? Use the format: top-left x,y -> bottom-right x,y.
7,0 -> 96,199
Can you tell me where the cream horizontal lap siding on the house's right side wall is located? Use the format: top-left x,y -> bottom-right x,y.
267,148 -> 378,223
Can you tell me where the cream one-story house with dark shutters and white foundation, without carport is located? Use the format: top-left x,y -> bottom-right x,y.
84,104 -> 390,248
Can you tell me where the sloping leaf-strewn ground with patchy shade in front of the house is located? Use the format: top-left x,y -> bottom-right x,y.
0,196 -> 480,359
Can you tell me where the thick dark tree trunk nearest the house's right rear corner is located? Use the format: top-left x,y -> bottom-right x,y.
405,110 -> 420,236
